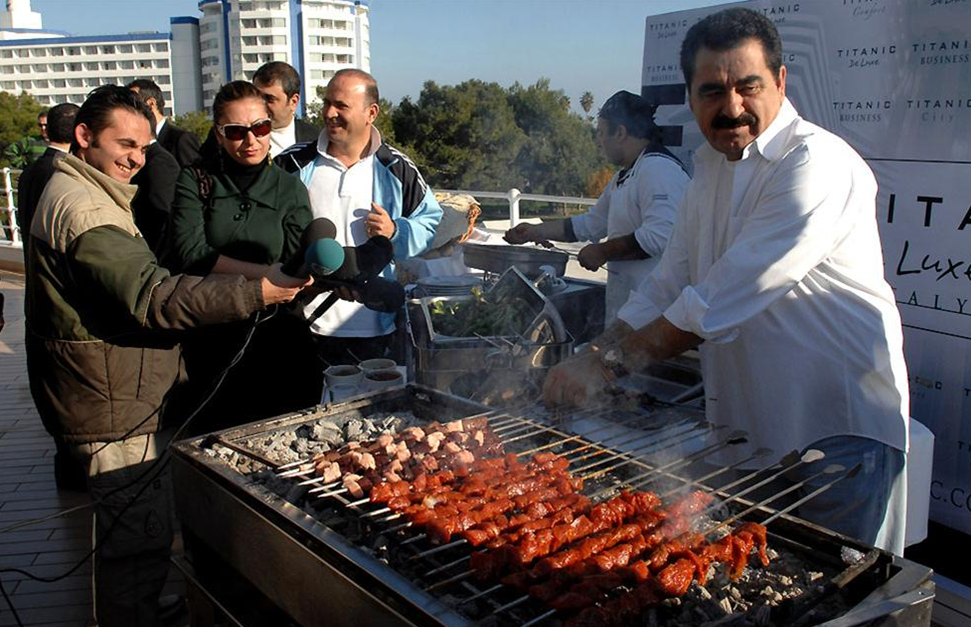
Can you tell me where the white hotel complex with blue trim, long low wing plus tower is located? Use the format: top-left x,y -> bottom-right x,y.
0,0 -> 371,115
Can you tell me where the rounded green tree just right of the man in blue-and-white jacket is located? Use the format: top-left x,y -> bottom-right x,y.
394,80 -> 526,189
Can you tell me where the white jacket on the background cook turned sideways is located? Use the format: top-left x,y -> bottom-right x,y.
571,151 -> 688,325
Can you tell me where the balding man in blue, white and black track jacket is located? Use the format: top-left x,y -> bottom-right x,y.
275,69 -> 442,364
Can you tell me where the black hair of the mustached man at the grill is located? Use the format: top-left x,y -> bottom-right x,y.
681,7 -> 782,90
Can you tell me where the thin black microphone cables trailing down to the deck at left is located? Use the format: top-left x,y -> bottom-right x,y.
0,310 -> 266,627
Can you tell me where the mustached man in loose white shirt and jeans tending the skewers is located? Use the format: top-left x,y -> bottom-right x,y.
544,8 -> 908,553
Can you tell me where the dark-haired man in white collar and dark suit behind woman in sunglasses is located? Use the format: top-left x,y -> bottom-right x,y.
253,61 -> 320,157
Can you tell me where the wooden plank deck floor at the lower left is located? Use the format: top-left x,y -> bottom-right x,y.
0,270 -> 182,627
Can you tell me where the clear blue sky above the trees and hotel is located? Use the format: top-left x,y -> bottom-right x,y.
31,0 -> 726,111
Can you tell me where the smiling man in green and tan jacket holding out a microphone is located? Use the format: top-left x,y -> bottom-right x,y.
26,85 -> 305,627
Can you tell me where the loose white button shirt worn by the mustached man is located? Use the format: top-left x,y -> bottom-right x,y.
620,100 -> 909,456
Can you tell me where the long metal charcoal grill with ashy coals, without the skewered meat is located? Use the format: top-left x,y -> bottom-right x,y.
173,386 -> 933,627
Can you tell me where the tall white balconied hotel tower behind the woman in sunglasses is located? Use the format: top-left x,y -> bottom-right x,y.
199,0 -> 371,113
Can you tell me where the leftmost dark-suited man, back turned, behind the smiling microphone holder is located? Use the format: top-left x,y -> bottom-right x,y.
17,103 -> 78,254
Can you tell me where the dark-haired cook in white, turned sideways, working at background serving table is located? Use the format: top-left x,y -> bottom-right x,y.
505,91 -> 688,325
